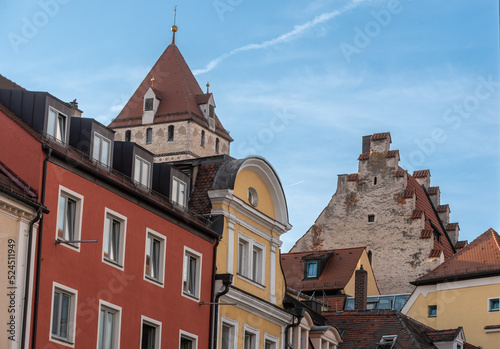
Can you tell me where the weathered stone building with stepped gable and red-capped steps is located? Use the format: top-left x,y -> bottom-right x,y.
290,133 -> 458,294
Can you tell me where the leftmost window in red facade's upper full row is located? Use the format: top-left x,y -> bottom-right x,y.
56,187 -> 83,248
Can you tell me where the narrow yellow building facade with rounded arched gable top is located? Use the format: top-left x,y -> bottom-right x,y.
208,157 -> 292,349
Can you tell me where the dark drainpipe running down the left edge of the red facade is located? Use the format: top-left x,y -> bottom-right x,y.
31,144 -> 52,349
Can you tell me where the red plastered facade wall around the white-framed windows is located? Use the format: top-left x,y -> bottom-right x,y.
33,162 -> 214,348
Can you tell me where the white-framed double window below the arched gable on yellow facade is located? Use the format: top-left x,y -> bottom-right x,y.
238,234 -> 265,285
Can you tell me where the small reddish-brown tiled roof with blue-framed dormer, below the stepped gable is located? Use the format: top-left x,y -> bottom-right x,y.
281,247 -> 365,291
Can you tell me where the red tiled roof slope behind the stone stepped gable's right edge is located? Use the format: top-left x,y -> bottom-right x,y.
406,174 -> 455,260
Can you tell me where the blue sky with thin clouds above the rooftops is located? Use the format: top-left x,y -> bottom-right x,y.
0,0 -> 500,251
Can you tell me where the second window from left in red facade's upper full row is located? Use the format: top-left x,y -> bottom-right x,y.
102,212 -> 126,267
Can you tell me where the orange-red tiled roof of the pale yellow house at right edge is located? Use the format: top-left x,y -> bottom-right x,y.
412,228 -> 500,286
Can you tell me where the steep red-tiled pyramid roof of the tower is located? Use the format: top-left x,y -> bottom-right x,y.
109,43 -> 232,141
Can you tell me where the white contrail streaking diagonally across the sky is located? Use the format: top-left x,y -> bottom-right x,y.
193,0 -> 364,75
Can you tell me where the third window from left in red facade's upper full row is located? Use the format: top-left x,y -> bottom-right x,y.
144,229 -> 165,283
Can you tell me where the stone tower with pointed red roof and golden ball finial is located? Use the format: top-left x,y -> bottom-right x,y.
109,25 -> 233,162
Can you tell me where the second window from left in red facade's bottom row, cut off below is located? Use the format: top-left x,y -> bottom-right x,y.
97,300 -> 121,349
